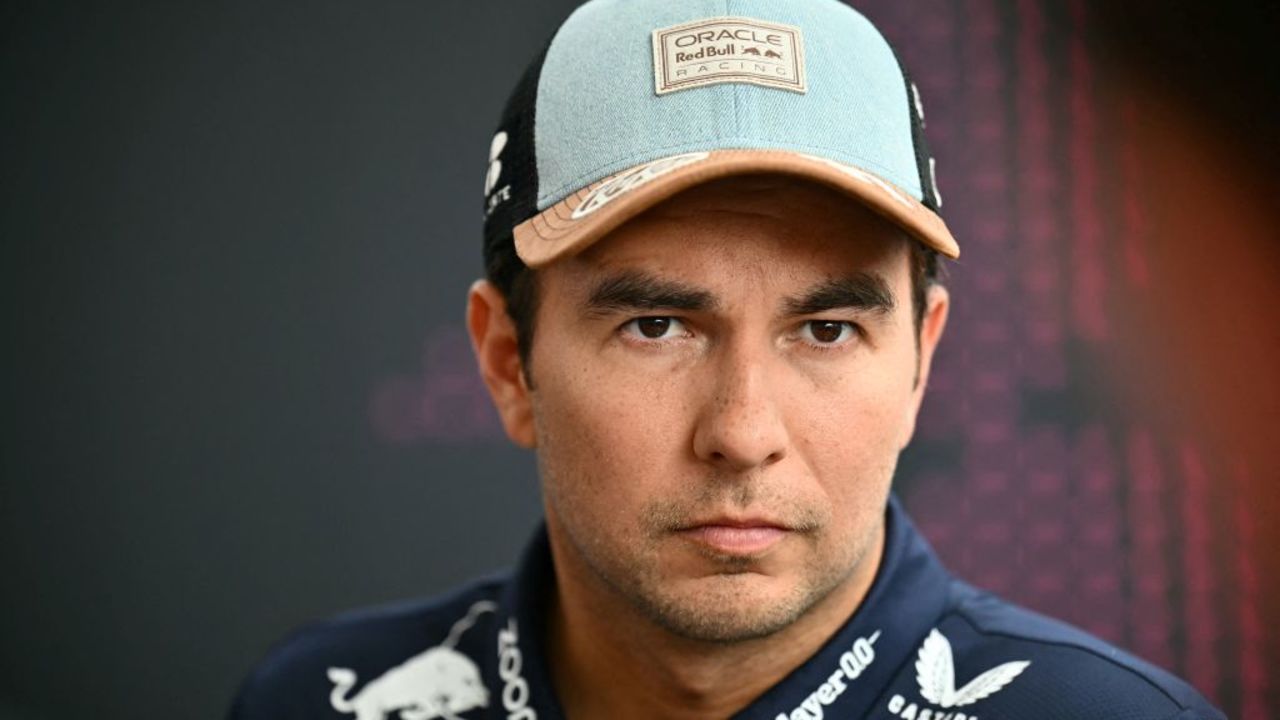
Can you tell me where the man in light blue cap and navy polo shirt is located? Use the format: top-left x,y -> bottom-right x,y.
232,0 -> 1221,720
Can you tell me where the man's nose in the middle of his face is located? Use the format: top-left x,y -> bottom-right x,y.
694,343 -> 788,471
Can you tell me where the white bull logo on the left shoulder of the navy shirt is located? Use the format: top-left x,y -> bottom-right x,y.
329,601 -> 497,720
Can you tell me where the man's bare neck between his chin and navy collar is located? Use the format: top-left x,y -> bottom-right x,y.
548,520 -> 884,720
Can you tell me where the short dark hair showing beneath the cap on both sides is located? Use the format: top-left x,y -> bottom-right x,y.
485,233 -> 942,384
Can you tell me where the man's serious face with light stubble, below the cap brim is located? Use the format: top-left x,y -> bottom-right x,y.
514,178 -> 946,641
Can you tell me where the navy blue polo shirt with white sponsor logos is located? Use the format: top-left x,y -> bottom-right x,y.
230,500 -> 1224,720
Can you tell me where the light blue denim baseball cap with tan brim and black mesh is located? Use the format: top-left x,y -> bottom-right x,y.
485,0 -> 960,268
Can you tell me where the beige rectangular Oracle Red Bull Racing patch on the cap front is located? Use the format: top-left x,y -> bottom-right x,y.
653,18 -> 809,95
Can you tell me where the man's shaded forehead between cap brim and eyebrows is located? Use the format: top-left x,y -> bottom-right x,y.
543,176 -> 913,293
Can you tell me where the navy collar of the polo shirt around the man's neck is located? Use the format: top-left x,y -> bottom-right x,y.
499,496 -> 950,720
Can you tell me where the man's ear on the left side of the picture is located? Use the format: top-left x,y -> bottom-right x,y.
467,281 -> 535,448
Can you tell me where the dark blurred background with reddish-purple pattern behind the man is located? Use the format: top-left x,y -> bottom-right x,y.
0,0 -> 1280,720
